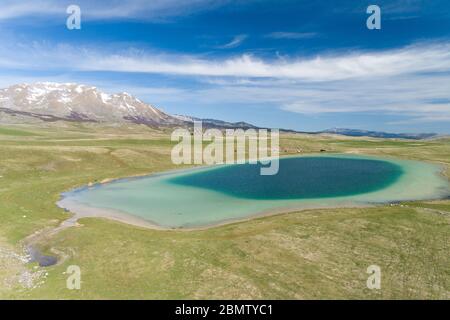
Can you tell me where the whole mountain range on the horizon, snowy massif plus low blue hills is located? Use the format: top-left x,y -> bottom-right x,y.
0,82 -> 436,139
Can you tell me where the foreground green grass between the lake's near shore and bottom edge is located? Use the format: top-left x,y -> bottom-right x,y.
10,208 -> 450,299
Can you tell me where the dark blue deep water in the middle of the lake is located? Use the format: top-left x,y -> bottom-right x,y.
169,157 -> 403,200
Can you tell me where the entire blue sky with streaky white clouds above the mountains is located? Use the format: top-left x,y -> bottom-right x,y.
0,0 -> 450,134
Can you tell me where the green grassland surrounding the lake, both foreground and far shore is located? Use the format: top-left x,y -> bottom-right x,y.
0,124 -> 450,299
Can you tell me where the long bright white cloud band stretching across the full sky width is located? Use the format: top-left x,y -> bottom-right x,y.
0,43 -> 450,82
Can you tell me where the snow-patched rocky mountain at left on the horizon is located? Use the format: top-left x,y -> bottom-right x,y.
0,82 -> 182,125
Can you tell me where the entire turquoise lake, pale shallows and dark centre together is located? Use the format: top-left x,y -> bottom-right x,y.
58,155 -> 450,228
